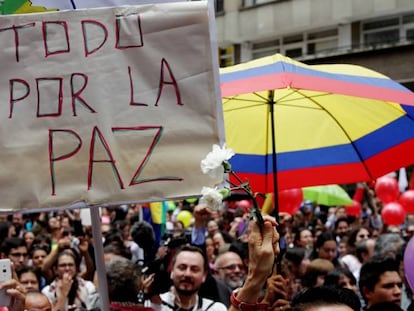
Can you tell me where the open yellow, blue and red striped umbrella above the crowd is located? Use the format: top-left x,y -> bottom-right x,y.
220,54 -> 414,215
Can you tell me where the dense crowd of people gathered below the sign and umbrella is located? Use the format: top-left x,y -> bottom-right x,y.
0,185 -> 414,311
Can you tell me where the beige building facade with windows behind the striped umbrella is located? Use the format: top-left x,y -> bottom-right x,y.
215,0 -> 414,90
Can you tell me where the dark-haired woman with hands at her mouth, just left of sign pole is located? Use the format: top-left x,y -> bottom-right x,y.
42,250 -> 98,311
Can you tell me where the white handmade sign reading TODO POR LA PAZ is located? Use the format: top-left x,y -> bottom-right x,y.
0,1 -> 222,211
